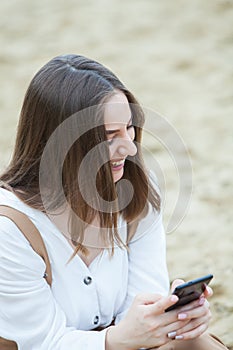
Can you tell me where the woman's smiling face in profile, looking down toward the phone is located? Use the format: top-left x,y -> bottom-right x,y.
104,91 -> 137,182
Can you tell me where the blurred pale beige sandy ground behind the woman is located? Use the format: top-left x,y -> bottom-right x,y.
0,0 -> 233,346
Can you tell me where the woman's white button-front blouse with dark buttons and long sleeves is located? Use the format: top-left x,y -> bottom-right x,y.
0,189 -> 169,350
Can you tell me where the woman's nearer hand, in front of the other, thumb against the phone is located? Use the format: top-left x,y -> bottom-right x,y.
106,294 -> 193,350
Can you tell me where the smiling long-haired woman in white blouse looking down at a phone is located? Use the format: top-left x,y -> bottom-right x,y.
0,55 -> 227,350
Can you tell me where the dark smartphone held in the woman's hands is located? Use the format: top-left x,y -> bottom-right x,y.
165,275 -> 213,312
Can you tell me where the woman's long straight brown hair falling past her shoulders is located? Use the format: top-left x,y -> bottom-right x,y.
0,55 -> 160,252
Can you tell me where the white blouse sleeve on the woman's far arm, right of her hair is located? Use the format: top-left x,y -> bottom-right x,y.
116,206 -> 169,323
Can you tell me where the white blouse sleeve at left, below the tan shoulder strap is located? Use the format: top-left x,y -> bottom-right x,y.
0,217 -> 106,350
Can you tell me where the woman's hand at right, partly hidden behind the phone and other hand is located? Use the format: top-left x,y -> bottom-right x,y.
166,280 -> 213,340
